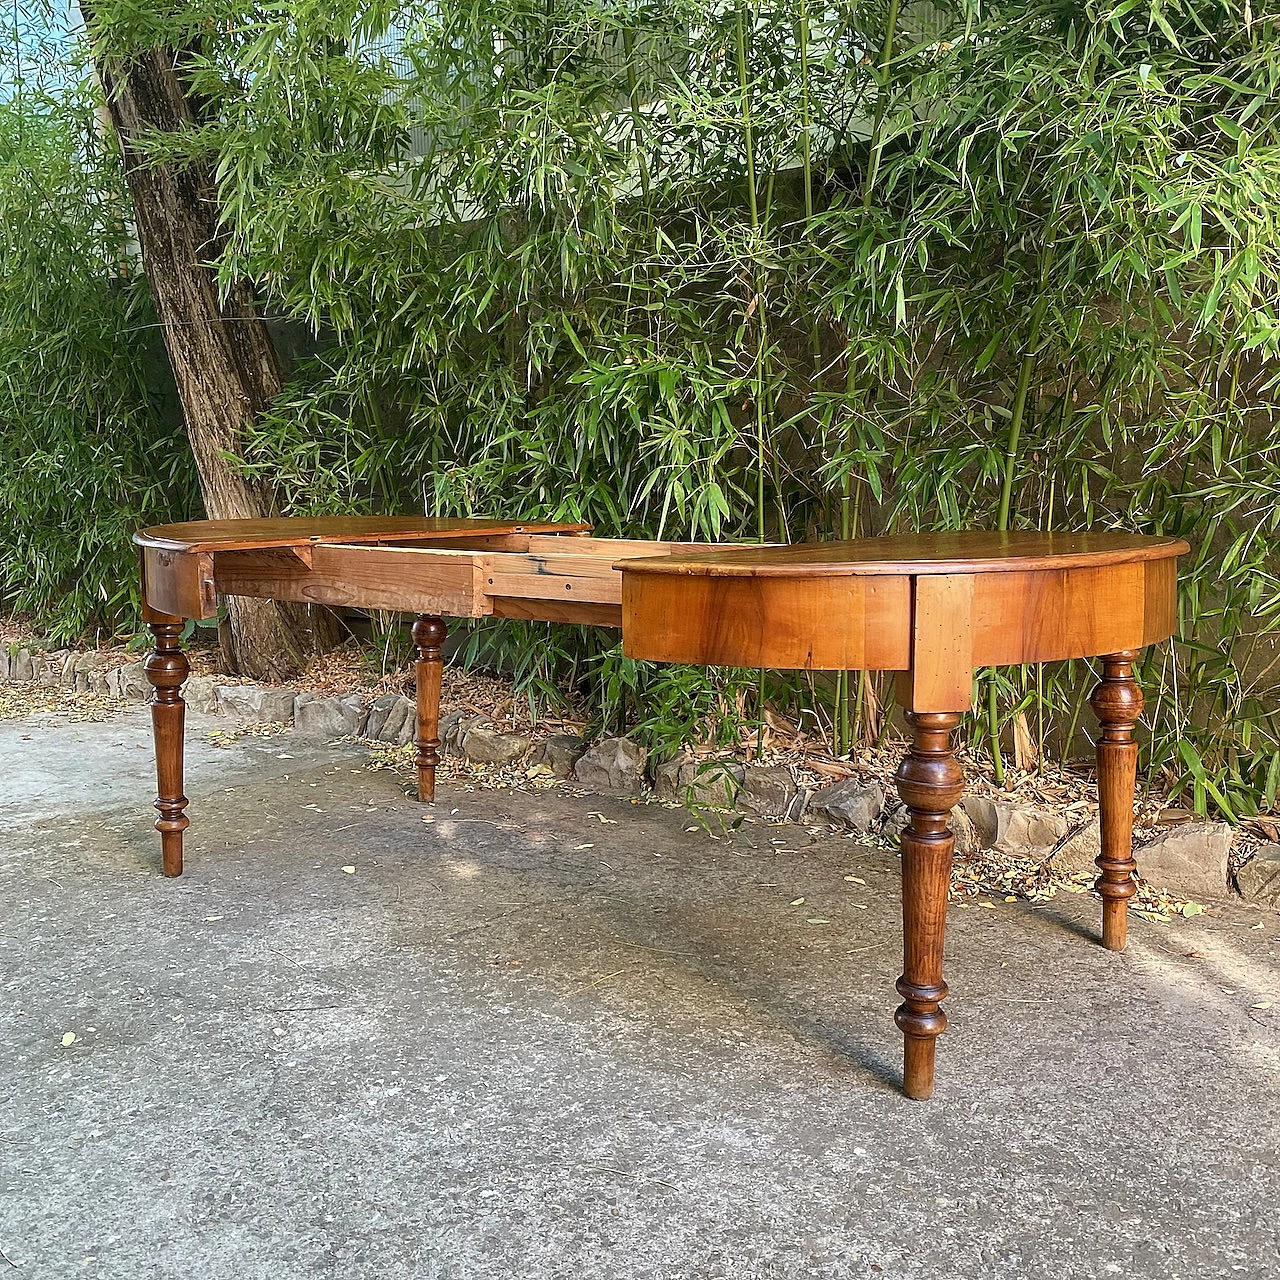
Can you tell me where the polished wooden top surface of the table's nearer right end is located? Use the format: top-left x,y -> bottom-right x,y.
614,530 -> 1190,577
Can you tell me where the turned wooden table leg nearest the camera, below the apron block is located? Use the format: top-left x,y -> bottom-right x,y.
893,712 -> 964,1098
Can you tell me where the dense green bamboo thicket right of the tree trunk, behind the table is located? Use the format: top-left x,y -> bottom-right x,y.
67,0 -> 1280,815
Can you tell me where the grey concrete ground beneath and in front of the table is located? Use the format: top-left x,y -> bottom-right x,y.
0,712 -> 1280,1280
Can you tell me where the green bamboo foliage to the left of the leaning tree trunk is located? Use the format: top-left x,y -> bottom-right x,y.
0,62 -> 195,644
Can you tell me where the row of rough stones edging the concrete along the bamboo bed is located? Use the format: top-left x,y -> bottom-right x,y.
0,649 -> 1254,911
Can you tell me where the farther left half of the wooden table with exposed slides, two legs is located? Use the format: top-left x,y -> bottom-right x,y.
137,517 -> 742,876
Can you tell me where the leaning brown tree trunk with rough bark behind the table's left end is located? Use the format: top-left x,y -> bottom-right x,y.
81,15 -> 339,680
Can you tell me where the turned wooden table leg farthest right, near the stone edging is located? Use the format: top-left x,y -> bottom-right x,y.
1089,650 -> 1142,951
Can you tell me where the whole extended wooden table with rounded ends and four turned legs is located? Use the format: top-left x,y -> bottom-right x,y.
134,516 -> 1189,1098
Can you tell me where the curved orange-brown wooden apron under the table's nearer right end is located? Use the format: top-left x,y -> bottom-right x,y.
622,558 -> 1178,680
